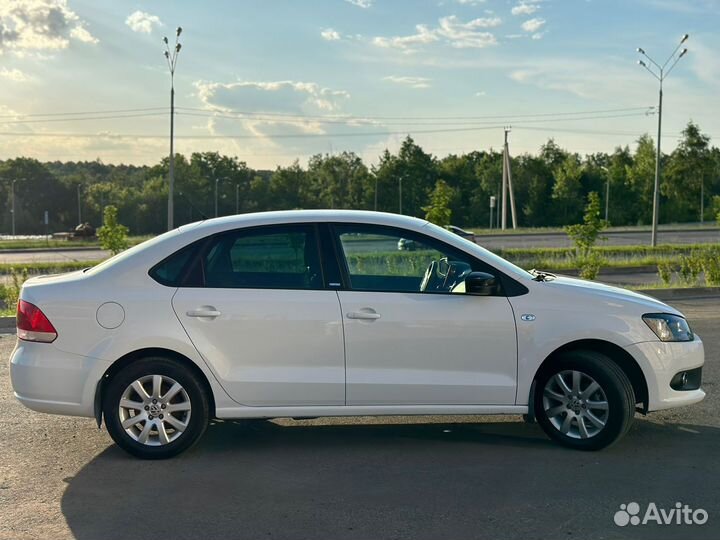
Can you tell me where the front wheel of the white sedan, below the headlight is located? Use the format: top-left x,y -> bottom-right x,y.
534,351 -> 635,450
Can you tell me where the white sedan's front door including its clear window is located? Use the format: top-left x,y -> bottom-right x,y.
334,224 -> 517,405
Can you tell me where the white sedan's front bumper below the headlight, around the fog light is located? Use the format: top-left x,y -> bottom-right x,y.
626,336 -> 705,411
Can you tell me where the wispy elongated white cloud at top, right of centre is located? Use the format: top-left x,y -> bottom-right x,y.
373,15 -> 502,52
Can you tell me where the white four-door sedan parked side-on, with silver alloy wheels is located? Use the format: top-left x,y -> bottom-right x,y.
11,211 -> 705,458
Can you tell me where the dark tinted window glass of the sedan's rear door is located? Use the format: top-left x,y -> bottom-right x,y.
203,226 -> 322,289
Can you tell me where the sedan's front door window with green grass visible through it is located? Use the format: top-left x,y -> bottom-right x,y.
335,225 -> 473,293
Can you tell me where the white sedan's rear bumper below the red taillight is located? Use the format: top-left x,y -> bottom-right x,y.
10,340 -> 110,417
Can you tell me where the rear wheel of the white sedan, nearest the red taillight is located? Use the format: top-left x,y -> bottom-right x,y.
103,357 -> 210,459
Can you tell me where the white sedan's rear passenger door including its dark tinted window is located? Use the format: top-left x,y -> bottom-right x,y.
173,224 -> 345,407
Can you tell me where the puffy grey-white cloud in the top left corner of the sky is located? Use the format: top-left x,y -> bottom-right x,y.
0,0 -> 98,54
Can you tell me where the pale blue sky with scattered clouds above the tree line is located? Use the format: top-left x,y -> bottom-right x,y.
0,0 -> 720,169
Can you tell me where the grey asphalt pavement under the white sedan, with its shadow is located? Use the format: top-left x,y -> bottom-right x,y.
0,299 -> 720,540
